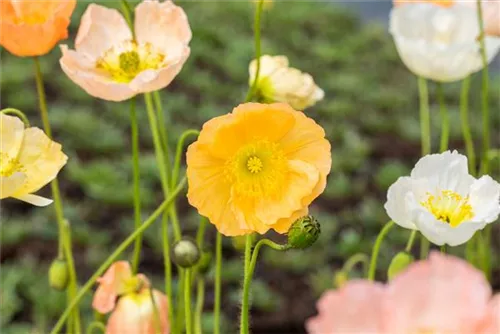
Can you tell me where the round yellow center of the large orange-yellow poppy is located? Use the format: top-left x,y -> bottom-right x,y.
225,140 -> 288,197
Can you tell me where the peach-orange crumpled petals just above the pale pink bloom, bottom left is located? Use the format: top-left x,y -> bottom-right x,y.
92,261 -> 149,314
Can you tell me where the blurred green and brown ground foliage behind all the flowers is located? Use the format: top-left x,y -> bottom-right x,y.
0,1 -> 500,334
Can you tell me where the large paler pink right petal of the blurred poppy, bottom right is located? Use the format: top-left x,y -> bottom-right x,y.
385,252 -> 491,334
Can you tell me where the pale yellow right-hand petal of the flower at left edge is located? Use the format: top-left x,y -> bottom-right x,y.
14,127 -> 68,197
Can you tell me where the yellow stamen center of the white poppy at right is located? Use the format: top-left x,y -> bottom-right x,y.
420,190 -> 474,227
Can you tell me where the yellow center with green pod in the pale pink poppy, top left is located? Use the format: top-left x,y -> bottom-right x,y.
96,41 -> 165,83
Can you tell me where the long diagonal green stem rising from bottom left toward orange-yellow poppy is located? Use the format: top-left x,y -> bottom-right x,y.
50,177 -> 186,334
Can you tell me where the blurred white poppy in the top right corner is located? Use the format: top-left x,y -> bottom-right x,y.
390,3 -> 500,82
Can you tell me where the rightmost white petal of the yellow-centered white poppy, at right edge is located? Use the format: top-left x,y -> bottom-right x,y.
469,175 -> 500,223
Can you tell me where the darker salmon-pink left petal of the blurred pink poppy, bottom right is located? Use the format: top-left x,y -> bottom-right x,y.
306,280 -> 385,334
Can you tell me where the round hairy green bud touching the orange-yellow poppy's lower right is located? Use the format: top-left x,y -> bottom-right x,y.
288,216 -> 321,249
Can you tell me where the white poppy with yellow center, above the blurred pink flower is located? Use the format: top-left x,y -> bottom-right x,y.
385,151 -> 500,246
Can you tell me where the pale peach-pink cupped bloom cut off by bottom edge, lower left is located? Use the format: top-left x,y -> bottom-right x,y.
106,289 -> 170,334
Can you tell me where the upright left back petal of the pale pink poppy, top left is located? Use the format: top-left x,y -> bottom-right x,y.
75,4 -> 133,61
